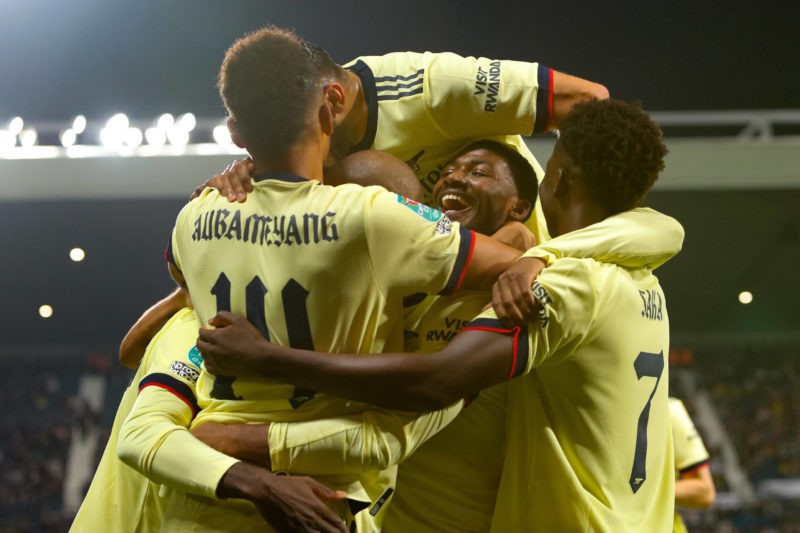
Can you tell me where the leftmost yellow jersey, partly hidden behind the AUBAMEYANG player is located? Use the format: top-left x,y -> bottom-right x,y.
70,309 -> 202,532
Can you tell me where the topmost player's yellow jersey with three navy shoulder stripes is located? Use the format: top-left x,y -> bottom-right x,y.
345,52 -> 552,242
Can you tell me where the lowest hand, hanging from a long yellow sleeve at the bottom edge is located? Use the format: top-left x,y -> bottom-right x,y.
217,463 -> 347,533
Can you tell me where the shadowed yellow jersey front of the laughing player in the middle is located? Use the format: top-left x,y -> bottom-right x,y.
383,291 -> 507,533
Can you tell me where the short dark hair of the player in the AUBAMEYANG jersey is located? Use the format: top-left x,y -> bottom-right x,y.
218,26 -> 342,156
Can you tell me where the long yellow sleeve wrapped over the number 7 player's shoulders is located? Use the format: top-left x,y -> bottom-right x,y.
522,208 -> 684,269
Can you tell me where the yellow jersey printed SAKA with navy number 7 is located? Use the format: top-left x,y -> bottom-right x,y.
467,258 -> 674,532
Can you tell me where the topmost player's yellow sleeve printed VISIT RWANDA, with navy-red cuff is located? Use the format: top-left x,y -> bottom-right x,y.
424,52 -> 552,138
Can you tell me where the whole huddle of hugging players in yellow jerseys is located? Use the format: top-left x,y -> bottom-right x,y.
72,23 -> 708,532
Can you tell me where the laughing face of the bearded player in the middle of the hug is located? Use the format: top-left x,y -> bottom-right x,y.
433,148 -> 518,235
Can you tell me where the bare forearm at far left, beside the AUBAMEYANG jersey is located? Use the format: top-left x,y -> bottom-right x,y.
119,287 -> 192,369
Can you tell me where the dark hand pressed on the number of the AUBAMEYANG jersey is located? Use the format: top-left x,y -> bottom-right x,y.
197,311 -> 271,376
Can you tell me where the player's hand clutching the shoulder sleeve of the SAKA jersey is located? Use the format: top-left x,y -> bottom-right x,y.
492,257 -> 545,327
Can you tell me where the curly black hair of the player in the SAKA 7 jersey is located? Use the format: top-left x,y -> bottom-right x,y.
558,100 -> 669,214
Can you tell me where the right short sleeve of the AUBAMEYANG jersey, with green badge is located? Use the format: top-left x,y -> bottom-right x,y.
364,188 -> 475,296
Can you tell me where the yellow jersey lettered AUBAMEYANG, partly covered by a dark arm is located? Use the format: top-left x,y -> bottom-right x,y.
166,174 -> 471,424
